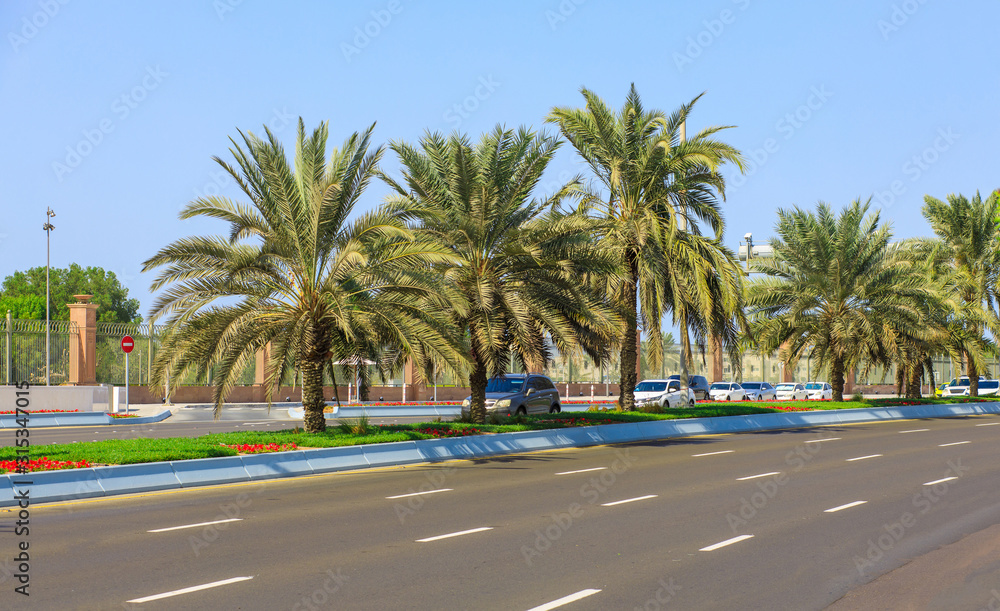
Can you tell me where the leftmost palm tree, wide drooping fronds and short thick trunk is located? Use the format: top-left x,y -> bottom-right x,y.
143,119 -> 459,432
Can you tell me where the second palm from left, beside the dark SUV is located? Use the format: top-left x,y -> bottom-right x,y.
385,127 -> 620,422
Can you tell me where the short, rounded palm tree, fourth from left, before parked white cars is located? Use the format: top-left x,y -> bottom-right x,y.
747,200 -> 934,401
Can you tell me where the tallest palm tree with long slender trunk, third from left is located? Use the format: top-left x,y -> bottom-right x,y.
547,85 -> 743,410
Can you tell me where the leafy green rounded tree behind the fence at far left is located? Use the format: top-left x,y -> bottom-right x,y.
0,263 -> 142,322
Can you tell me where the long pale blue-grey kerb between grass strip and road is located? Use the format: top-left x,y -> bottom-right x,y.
0,403 -> 1000,507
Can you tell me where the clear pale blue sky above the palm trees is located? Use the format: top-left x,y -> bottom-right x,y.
0,0 -> 1000,316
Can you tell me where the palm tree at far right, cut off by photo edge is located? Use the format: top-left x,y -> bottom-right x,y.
923,192 -> 1000,397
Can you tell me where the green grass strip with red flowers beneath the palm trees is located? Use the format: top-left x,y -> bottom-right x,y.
0,398 -> 997,472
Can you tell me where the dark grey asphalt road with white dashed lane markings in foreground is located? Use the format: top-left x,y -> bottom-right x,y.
0,416 -> 1000,611
